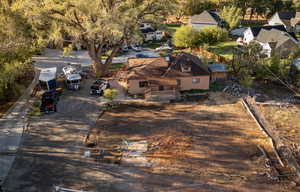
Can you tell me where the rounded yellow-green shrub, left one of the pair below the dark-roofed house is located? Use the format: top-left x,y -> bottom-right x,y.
173,25 -> 199,48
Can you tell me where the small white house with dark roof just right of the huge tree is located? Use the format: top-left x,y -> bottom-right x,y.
140,23 -> 164,41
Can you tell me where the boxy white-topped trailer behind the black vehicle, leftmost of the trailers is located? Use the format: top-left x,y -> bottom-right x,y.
39,67 -> 57,91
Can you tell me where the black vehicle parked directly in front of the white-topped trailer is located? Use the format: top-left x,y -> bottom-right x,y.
40,91 -> 59,113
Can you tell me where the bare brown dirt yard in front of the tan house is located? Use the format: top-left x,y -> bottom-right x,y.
86,93 -> 296,192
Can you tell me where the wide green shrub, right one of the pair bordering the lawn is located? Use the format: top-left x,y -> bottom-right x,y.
198,27 -> 228,45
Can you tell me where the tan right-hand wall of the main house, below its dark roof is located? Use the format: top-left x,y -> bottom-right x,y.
178,75 -> 210,91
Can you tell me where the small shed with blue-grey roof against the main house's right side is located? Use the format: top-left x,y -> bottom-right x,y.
208,63 -> 228,82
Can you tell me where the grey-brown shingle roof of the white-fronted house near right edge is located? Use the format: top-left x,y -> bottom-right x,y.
256,29 -> 298,47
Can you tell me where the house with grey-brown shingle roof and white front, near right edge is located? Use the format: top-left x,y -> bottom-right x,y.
255,29 -> 299,58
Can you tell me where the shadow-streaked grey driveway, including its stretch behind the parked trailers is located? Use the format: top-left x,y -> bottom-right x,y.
0,50 -> 101,192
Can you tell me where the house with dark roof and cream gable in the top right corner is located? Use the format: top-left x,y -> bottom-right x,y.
268,11 -> 300,32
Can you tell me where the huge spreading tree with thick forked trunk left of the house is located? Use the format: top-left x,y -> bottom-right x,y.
15,0 -> 173,75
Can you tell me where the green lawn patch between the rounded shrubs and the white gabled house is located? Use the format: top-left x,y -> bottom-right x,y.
208,41 -> 237,59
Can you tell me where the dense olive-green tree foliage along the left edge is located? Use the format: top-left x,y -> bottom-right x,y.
0,0 -> 32,101
